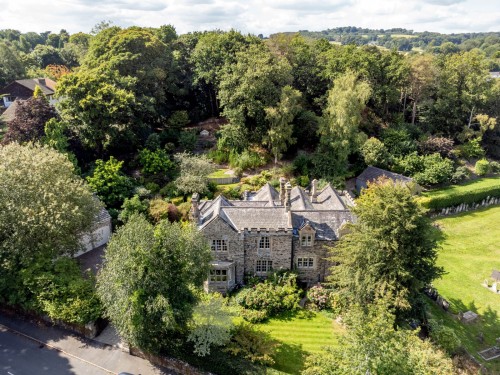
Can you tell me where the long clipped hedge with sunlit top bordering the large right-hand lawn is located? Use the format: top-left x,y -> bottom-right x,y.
418,177 -> 500,210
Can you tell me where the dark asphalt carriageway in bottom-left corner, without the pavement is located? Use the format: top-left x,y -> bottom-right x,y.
0,326 -> 112,375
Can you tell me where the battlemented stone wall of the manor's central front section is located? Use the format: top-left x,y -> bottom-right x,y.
244,229 -> 292,275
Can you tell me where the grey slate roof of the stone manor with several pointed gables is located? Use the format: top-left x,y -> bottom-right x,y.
198,184 -> 354,240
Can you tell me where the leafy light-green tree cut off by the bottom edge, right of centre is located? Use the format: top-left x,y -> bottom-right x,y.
302,302 -> 454,375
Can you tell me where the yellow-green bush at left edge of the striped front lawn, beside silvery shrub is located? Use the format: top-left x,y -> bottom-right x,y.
225,322 -> 279,366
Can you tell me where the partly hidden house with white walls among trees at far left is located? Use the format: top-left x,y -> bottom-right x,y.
0,78 -> 56,108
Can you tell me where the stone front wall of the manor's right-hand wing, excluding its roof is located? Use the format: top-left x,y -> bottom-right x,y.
293,237 -> 335,286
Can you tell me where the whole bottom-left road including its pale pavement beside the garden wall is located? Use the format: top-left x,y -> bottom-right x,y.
0,314 -> 173,375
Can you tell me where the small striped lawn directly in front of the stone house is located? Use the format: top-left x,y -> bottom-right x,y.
257,310 -> 343,374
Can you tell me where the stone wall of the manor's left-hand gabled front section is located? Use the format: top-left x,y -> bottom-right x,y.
202,218 -> 245,283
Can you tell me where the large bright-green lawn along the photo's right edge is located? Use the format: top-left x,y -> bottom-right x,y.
434,206 -> 500,373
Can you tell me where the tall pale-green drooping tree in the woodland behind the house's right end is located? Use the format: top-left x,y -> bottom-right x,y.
320,72 -> 371,177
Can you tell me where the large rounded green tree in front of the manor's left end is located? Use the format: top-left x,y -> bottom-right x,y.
97,216 -> 210,353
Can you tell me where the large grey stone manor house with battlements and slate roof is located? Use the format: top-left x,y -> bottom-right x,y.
191,179 -> 354,292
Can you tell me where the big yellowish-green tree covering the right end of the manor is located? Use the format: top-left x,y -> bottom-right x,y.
330,180 -> 443,318
